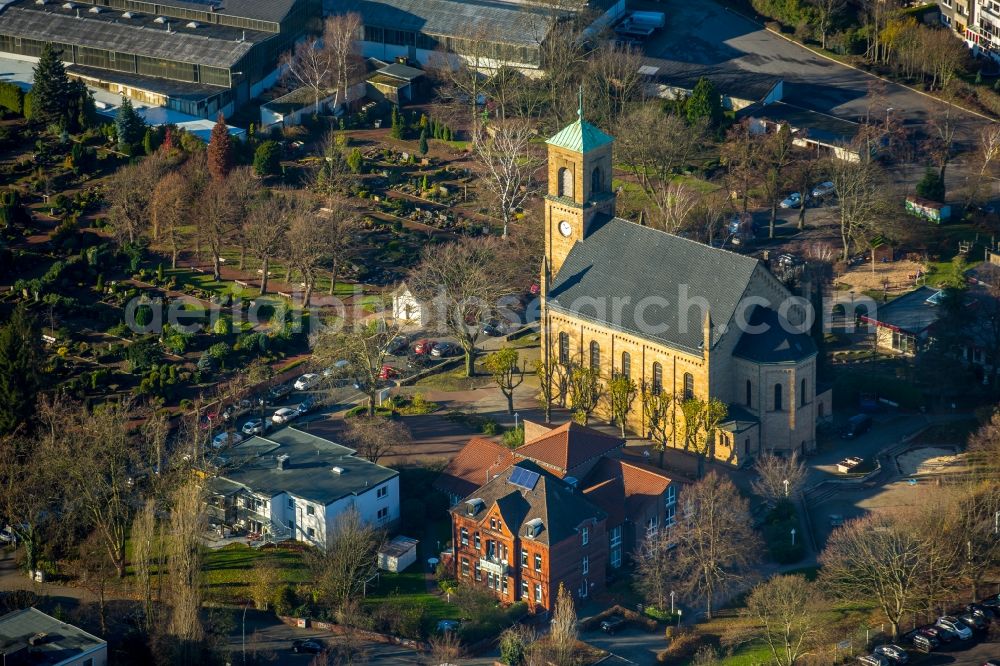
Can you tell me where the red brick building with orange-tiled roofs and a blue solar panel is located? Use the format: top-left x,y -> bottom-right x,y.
435,423 -> 677,609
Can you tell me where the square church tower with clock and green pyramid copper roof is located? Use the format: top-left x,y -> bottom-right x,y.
542,90 -> 615,280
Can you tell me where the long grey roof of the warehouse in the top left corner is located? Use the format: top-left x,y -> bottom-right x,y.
0,5 -> 264,69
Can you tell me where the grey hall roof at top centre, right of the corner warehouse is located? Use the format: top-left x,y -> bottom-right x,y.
337,0 -> 558,46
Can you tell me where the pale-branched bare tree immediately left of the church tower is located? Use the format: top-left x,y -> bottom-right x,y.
472,118 -> 542,238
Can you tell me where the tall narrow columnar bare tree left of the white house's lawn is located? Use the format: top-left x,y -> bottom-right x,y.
167,479 -> 207,652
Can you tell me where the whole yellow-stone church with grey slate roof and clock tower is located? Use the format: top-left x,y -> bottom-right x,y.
541,106 -> 832,465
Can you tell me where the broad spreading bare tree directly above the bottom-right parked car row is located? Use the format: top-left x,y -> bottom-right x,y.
820,512 -> 928,639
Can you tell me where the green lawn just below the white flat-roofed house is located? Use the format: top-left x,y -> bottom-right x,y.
201,544 -> 309,603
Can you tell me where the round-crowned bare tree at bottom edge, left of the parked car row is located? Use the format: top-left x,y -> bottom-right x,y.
746,576 -> 828,666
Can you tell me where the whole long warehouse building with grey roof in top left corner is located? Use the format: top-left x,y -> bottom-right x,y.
0,0 -> 321,118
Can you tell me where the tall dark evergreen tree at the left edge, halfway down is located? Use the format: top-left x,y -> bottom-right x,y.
0,305 -> 42,435
